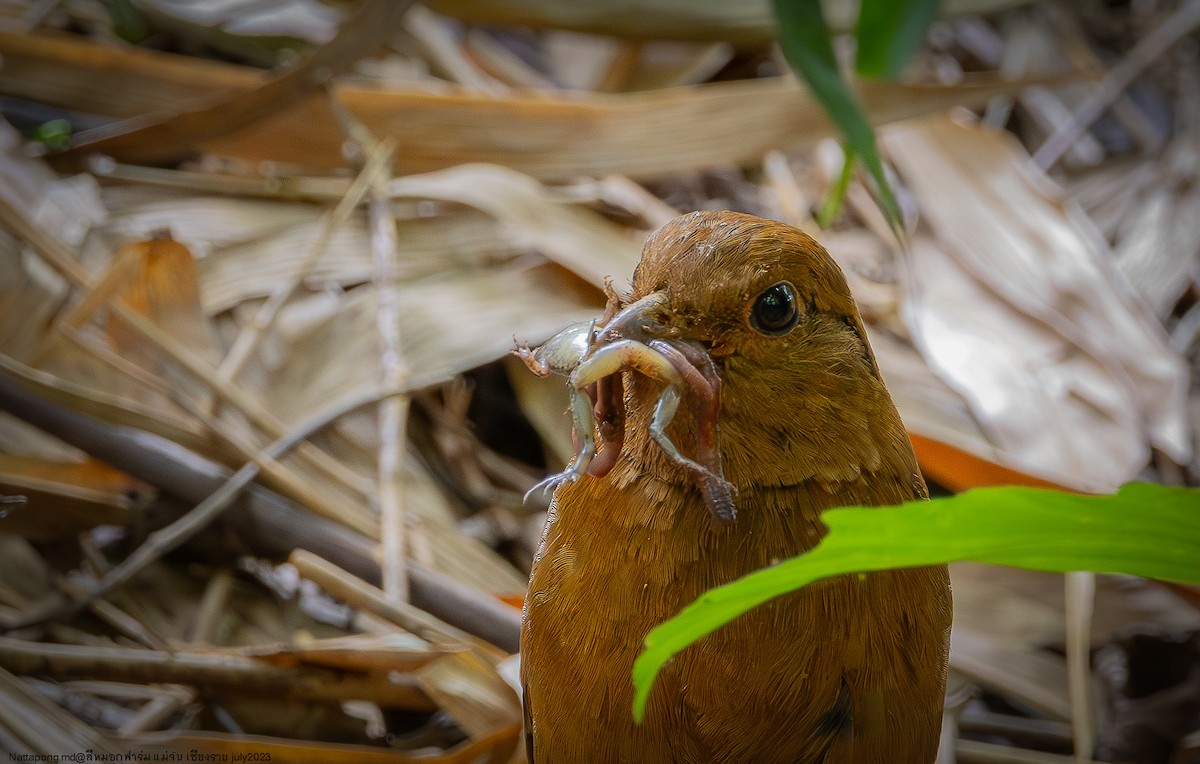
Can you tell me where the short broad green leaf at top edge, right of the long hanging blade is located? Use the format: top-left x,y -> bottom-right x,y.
854,0 -> 938,78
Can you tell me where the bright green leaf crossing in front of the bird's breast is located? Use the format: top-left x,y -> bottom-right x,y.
634,483 -> 1200,721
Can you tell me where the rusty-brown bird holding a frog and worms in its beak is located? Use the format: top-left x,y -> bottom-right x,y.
521,212 -> 950,764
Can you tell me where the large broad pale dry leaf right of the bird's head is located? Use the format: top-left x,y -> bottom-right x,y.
882,116 -> 1190,489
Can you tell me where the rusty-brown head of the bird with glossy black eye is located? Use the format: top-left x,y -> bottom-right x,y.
604,212 -> 914,489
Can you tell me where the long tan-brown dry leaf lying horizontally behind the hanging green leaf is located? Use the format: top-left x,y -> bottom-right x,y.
216,74 -> 1051,181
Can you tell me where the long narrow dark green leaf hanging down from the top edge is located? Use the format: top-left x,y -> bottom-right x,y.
774,0 -> 900,230
